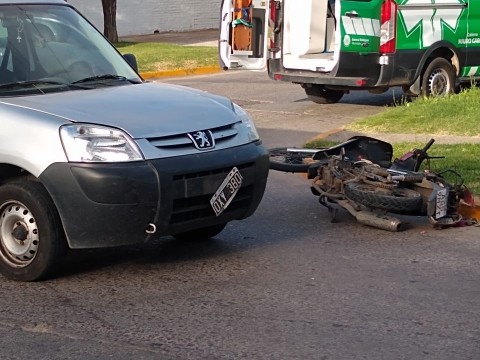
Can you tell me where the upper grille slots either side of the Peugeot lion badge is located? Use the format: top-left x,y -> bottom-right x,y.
148,124 -> 238,150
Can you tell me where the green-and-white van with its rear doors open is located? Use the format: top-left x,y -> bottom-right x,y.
219,0 -> 480,104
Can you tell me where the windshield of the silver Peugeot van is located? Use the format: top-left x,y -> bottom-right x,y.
0,4 -> 142,96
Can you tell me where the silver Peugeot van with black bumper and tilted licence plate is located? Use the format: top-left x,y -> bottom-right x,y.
0,0 -> 268,281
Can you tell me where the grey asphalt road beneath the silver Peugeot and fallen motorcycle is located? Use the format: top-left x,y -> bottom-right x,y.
0,73 -> 480,360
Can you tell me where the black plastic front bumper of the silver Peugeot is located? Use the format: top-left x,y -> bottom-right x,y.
40,143 -> 269,248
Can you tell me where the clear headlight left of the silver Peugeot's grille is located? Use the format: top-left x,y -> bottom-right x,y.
60,124 -> 143,162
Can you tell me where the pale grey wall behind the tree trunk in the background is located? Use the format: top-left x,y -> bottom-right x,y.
67,0 -> 221,36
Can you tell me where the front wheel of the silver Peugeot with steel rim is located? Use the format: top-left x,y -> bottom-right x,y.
0,181 -> 67,281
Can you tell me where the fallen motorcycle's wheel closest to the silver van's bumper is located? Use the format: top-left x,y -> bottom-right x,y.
268,148 -> 319,173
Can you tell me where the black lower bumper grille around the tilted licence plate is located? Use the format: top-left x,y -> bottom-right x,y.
170,163 -> 254,225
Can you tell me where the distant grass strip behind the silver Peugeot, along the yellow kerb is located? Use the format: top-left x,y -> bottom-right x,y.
115,42 -> 218,72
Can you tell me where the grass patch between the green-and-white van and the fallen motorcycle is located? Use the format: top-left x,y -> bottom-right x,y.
347,87 -> 480,136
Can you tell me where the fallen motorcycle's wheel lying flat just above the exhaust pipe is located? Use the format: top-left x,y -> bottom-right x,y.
344,182 -> 422,214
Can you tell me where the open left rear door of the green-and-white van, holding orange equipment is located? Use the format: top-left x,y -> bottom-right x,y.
218,0 -> 271,70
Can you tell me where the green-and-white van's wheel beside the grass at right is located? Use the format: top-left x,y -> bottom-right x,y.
422,58 -> 456,97
